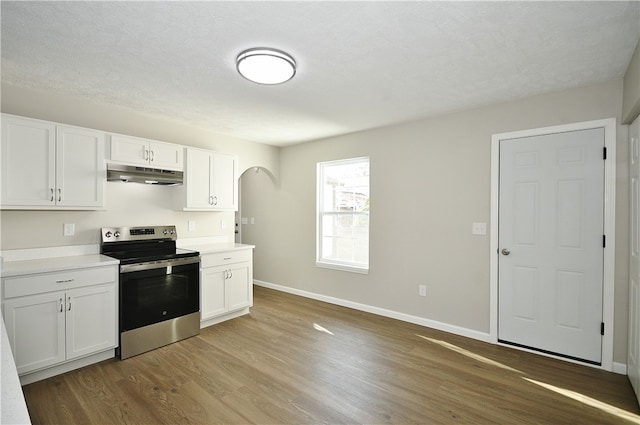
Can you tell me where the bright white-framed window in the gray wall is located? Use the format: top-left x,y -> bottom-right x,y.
316,158 -> 369,273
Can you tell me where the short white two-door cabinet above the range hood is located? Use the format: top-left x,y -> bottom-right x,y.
109,135 -> 184,171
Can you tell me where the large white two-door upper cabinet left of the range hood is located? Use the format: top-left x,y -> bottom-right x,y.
0,114 -> 105,210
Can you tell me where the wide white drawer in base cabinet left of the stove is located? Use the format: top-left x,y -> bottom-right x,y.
2,267 -> 116,298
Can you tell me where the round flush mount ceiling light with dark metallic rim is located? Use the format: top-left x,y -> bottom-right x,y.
236,47 -> 296,84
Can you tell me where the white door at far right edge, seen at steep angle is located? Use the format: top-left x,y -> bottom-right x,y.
627,112 -> 640,402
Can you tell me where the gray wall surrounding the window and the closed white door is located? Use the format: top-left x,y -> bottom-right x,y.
242,79 -> 629,363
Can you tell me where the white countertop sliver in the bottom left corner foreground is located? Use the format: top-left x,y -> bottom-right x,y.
0,315 -> 31,424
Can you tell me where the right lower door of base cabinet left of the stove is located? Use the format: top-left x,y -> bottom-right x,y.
65,284 -> 116,360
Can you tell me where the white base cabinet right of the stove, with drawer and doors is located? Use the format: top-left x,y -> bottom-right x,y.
200,248 -> 253,327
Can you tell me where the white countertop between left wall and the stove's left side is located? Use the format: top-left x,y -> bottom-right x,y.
0,254 -> 120,277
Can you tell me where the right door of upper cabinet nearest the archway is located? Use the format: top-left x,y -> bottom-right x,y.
211,153 -> 238,211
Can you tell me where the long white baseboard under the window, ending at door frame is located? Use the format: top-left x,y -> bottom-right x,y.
253,279 -> 491,342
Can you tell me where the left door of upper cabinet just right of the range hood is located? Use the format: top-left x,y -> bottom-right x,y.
184,149 -> 213,210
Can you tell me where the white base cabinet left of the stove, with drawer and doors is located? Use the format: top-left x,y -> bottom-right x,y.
2,266 -> 117,375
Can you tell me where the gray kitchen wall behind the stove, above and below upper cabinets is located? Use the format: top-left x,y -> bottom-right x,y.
0,84 -> 280,250
